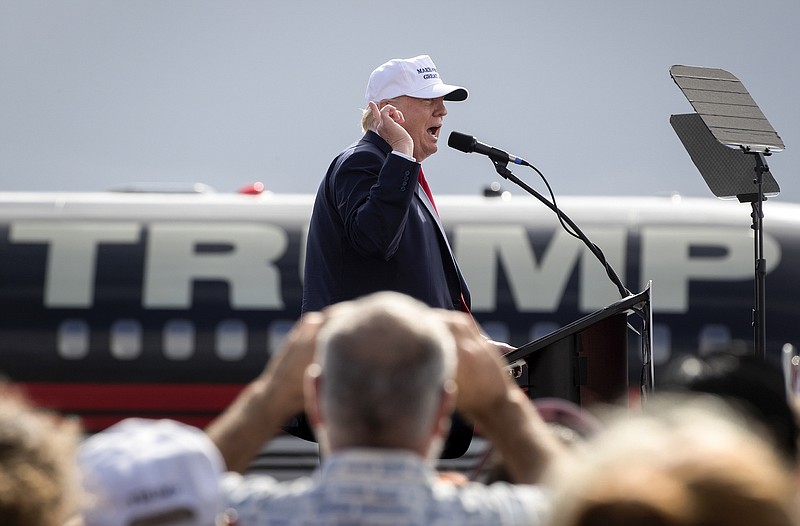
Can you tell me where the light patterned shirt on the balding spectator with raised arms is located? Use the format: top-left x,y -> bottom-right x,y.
223,449 -> 549,526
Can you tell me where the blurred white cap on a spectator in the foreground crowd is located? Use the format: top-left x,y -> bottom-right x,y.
78,418 -> 224,526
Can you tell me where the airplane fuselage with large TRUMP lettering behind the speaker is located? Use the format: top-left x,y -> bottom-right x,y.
0,193 -> 800,427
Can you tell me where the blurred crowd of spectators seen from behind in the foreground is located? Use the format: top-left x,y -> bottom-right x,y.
0,292 -> 800,526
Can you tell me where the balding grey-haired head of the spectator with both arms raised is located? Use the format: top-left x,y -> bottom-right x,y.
317,292 -> 456,447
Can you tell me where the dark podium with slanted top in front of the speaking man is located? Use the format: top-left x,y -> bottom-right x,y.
505,284 -> 653,406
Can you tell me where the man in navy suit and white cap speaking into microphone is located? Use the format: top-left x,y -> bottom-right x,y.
303,55 -> 469,312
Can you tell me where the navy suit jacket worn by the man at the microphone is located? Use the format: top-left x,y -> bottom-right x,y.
303,131 -> 470,312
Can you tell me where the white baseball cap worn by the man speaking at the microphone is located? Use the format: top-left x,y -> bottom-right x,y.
366,55 -> 469,102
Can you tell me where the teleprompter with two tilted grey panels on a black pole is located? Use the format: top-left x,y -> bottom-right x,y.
670,65 -> 784,359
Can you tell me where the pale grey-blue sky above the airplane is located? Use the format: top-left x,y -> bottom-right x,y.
0,0 -> 800,202
